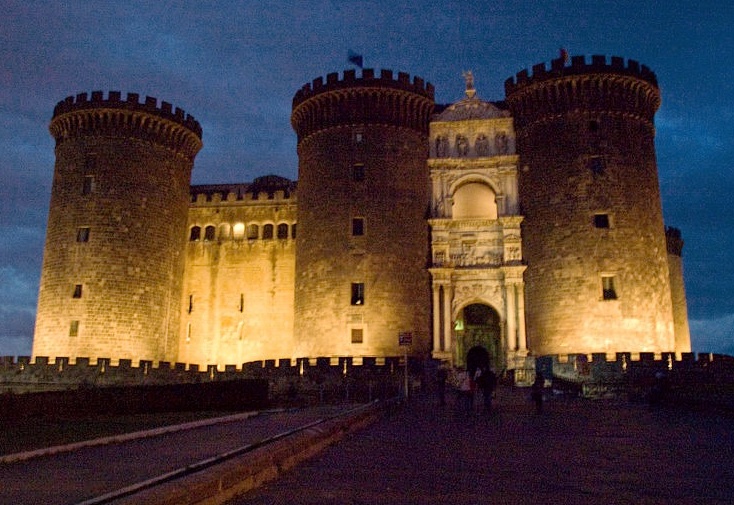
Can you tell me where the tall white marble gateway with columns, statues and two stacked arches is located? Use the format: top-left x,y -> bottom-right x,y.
428,73 -> 528,374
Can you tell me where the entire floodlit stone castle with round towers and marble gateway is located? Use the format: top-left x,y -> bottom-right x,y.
33,56 -> 690,370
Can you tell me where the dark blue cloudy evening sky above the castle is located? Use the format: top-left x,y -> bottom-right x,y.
0,0 -> 734,355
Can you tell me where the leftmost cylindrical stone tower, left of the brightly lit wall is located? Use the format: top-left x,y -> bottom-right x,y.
33,92 -> 202,360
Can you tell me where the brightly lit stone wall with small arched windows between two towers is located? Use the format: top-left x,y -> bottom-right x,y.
176,180 -> 297,366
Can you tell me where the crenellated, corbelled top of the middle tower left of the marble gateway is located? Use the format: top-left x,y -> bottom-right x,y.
291,69 -> 434,142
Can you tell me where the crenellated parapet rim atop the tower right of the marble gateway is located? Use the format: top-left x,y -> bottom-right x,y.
505,55 -> 658,95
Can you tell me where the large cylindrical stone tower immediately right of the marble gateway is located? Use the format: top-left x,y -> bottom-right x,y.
505,56 -> 675,355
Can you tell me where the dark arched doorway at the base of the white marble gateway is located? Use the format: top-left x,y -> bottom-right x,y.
454,303 -> 507,373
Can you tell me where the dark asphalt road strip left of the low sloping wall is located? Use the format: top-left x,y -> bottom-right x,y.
0,408 -> 354,505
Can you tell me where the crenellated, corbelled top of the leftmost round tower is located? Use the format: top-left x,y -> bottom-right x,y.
49,91 -> 202,159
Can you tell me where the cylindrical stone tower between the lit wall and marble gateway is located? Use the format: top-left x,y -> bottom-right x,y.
291,69 -> 434,357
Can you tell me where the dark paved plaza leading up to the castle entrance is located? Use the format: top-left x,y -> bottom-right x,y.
231,387 -> 734,505
